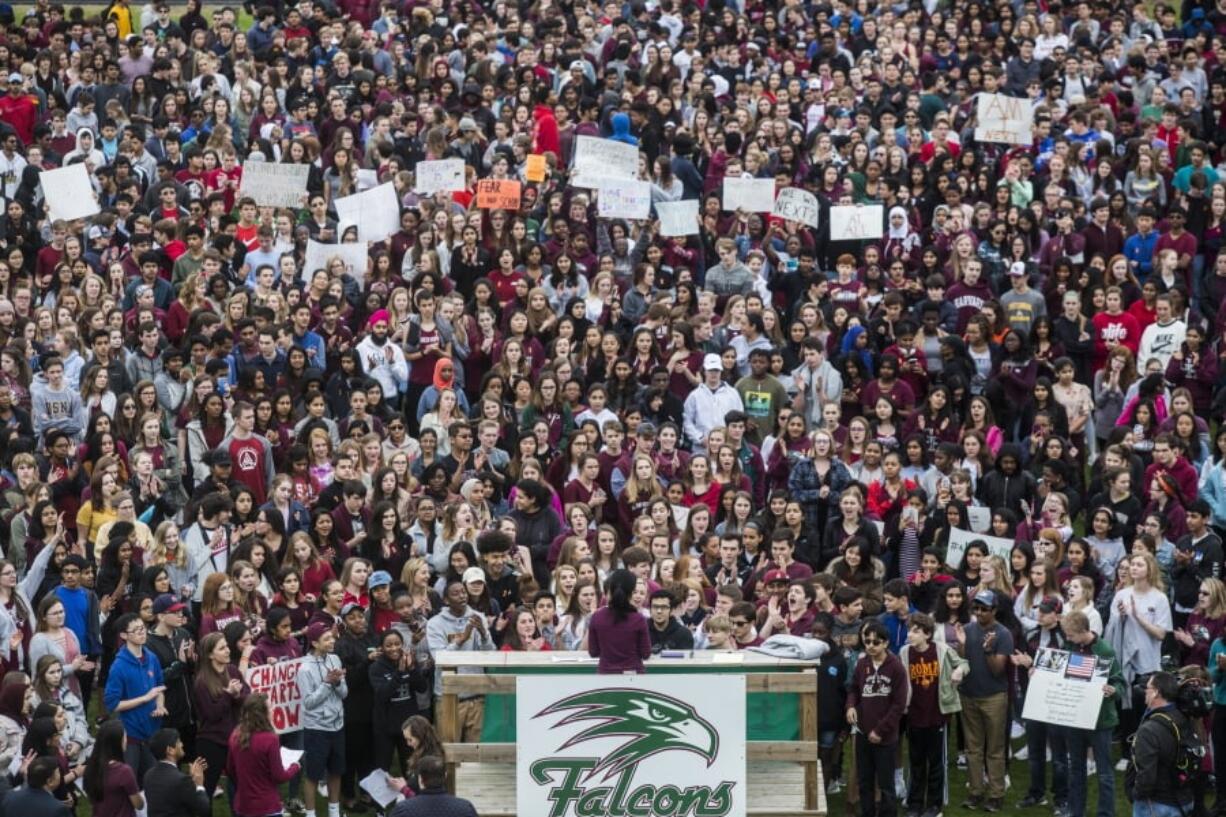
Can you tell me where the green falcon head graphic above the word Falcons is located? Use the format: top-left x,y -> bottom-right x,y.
536,688 -> 720,780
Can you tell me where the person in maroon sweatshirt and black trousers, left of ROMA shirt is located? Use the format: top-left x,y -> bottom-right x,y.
846,621 -> 912,817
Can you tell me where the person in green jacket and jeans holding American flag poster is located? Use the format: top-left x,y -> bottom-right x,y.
1060,610 -> 1124,817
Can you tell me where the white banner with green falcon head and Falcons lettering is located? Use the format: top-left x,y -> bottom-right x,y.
515,675 -> 748,817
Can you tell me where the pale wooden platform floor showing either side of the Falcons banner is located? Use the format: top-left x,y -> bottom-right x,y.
456,761 -> 826,817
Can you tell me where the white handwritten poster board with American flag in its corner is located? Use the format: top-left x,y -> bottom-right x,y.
1021,646 -> 1111,726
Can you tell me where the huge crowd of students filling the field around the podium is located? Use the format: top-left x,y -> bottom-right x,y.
0,0 -> 1226,817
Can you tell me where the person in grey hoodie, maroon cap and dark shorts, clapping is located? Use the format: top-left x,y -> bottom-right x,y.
297,622 -> 349,817
